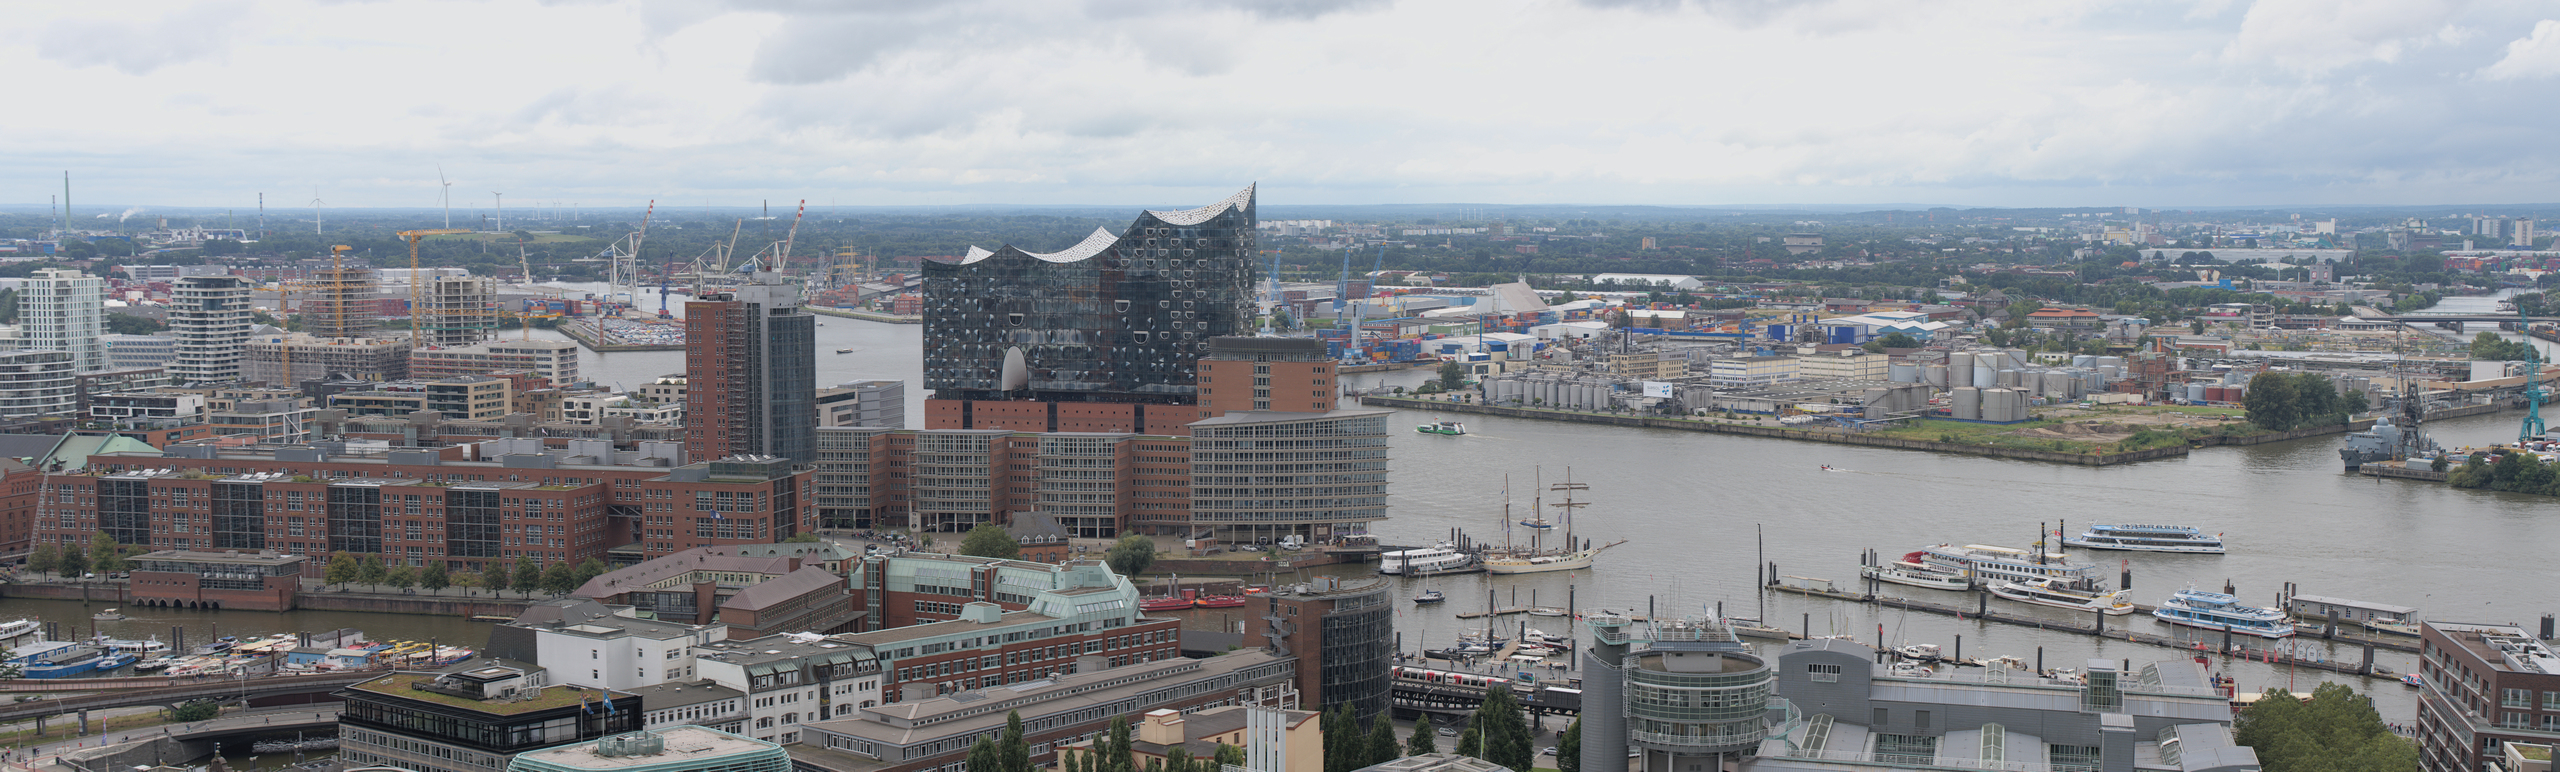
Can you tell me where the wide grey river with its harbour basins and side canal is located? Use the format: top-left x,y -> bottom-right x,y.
15,291 -> 2560,723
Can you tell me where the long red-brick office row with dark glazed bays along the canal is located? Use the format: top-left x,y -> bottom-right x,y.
36,442 -> 812,570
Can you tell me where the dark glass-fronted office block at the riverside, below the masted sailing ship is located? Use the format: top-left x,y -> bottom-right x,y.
1244,575 -> 1395,723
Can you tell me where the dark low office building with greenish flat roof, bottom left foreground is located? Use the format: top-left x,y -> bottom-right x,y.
338,660 -> 643,772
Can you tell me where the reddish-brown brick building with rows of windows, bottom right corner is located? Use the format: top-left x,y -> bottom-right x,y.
2417,621 -> 2560,772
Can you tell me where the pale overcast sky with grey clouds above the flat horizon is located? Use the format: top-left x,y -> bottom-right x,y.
15,0 -> 2560,212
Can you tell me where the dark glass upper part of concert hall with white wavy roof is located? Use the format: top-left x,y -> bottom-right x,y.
924,187 -> 1260,404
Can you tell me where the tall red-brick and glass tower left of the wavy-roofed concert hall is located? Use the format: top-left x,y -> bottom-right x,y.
684,271 -> 817,465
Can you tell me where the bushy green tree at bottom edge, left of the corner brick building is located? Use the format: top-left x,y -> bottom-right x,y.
2235,683 -> 2417,772
